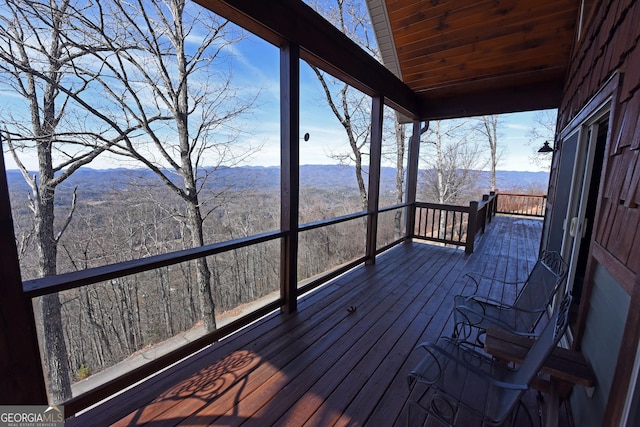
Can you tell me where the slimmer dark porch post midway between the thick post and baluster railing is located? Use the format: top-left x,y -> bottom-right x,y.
366,96 -> 384,264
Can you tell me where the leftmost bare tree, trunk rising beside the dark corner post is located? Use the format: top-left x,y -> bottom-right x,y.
0,0 -> 124,403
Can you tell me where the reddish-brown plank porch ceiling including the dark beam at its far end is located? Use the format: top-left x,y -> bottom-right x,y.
376,0 -> 579,118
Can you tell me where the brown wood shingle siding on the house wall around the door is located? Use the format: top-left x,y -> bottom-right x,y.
550,0 -> 640,425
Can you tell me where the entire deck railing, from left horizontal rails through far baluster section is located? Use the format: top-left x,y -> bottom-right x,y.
15,193 -> 536,413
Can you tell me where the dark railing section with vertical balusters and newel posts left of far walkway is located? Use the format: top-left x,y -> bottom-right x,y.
411,192 -> 497,254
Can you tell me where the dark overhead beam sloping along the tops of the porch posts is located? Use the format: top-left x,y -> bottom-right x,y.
196,0 -> 420,118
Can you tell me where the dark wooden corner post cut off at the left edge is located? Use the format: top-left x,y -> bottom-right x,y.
0,136 -> 47,405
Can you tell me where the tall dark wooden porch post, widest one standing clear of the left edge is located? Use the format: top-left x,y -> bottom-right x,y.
280,43 -> 300,312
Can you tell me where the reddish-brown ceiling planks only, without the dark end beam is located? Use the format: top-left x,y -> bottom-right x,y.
389,1 -> 576,86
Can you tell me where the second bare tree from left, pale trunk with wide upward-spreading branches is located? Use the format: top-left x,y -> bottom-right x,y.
72,0 -> 257,331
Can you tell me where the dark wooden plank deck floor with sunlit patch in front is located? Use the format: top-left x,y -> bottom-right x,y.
68,216 -> 568,426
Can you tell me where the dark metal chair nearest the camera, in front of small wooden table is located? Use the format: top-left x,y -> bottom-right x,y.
407,293 -> 571,426
